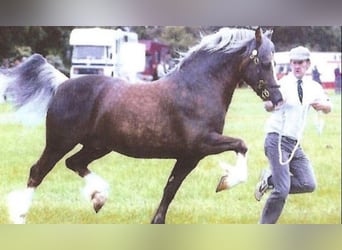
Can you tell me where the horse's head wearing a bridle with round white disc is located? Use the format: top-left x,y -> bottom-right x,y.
240,28 -> 283,106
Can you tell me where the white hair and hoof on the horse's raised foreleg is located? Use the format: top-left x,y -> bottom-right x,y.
216,153 -> 248,192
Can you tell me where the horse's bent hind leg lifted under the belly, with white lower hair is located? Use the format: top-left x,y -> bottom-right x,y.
66,145 -> 111,213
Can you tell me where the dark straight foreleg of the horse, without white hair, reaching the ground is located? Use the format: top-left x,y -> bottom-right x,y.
151,159 -> 199,224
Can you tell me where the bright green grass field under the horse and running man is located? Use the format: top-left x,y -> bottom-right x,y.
0,89 -> 341,224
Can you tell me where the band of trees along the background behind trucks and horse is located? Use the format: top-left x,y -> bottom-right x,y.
0,26 -> 341,66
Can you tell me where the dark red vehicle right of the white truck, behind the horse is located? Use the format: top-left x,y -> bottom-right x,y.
139,40 -> 169,80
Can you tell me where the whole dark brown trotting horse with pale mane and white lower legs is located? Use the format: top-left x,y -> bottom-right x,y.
5,28 -> 282,224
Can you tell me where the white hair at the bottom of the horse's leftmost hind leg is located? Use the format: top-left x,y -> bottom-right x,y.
7,188 -> 35,224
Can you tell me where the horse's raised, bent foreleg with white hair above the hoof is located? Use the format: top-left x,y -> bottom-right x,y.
200,134 -> 248,192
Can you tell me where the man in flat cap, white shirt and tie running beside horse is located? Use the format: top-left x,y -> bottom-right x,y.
255,46 -> 332,224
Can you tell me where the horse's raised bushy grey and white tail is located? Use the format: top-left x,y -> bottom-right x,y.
3,54 -> 68,125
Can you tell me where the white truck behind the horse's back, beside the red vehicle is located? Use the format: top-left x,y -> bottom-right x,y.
69,28 -> 145,80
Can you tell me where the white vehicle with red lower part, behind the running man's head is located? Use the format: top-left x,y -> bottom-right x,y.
274,51 -> 341,88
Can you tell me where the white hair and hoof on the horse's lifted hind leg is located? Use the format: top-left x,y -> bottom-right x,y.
83,173 -> 109,213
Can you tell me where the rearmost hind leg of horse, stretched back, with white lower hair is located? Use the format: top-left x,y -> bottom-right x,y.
8,147 -> 72,224
